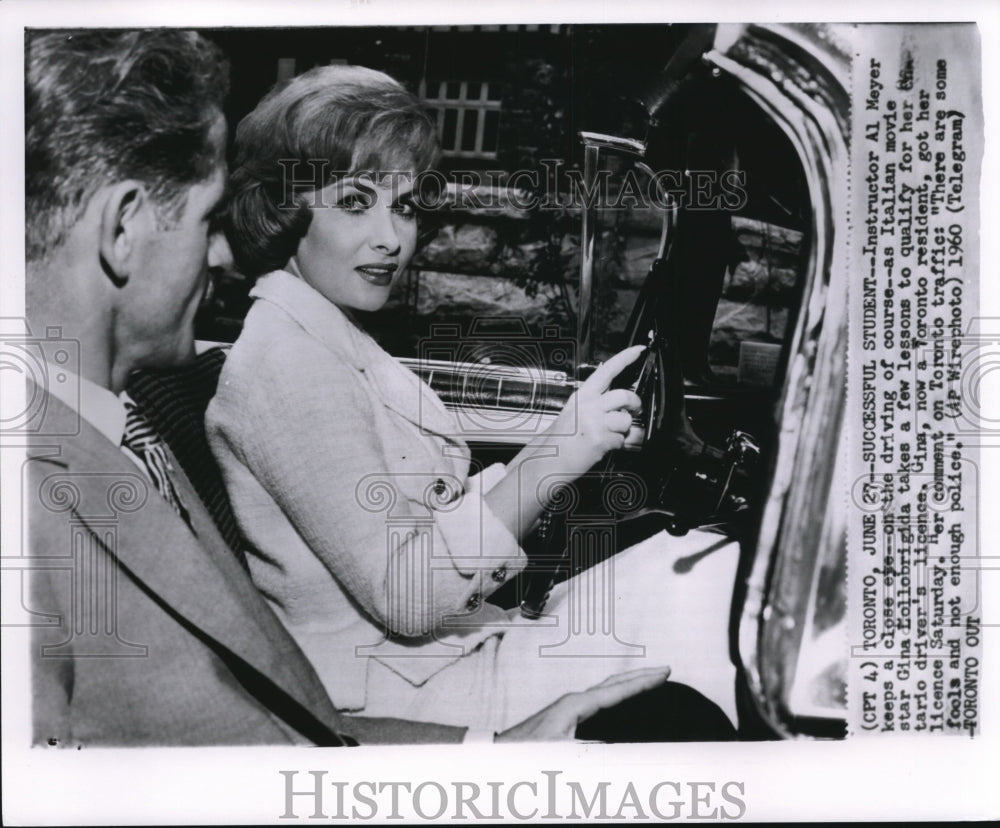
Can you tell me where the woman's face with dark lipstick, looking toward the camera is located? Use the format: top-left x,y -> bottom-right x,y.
289,174 -> 417,311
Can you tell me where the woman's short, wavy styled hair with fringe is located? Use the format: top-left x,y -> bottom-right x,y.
224,65 -> 440,276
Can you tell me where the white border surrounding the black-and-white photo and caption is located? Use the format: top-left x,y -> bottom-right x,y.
0,0 -> 1000,825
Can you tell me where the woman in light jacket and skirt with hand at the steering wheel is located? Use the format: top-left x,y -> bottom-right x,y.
207,66 -> 744,730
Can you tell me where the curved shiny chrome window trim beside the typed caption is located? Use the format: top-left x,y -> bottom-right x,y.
703,26 -> 849,737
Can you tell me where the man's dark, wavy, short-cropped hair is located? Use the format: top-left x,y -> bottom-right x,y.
24,29 -> 229,262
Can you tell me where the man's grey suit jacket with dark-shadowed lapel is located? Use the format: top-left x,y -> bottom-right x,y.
25,386 -> 464,746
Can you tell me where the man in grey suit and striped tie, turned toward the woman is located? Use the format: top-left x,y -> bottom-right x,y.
25,30 -> 667,745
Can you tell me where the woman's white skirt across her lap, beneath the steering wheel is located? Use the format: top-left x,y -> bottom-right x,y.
352,531 -> 739,732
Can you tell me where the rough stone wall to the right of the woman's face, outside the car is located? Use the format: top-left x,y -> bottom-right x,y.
376,205 -> 802,381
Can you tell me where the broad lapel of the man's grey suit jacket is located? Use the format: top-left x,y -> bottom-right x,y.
29,398 -> 337,740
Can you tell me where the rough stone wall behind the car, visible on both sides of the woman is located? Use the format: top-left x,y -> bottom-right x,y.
199,202 -> 803,390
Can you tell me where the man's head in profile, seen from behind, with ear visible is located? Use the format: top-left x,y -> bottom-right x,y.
25,30 -> 228,385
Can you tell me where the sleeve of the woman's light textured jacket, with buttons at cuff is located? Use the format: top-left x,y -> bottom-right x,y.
209,336 -> 526,636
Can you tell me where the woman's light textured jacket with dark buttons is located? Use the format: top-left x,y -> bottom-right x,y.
206,271 -> 526,709
